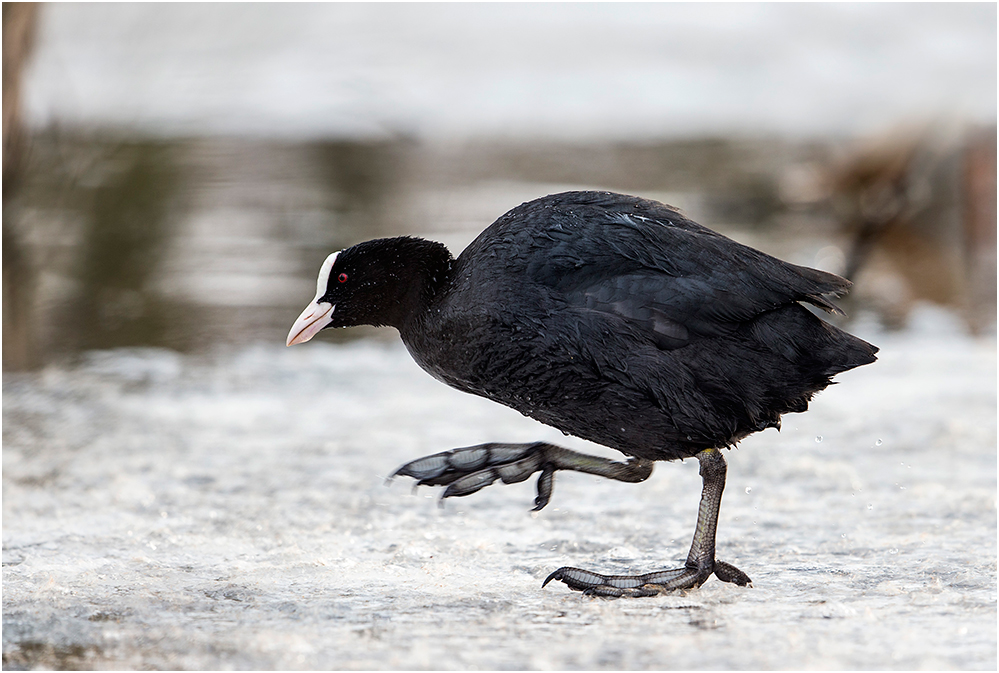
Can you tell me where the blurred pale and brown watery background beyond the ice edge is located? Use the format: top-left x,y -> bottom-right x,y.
4,3 -> 996,369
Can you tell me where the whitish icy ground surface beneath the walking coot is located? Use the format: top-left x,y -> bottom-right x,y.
3,321 -> 996,670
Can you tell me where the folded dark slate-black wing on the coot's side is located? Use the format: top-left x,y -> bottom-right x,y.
527,192 -> 850,350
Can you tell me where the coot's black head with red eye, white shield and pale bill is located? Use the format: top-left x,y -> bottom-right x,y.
287,236 -> 453,346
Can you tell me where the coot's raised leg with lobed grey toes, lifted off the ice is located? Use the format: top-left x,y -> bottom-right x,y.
389,442 -> 652,511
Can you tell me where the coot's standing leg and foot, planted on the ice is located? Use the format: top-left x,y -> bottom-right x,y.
542,449 -> 750,597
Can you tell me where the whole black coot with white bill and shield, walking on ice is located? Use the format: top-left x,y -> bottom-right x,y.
288,192 -> 878,596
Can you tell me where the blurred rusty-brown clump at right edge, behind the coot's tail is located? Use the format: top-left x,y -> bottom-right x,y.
831,126 -> 996,332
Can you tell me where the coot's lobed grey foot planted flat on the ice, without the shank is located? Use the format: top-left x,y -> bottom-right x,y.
541,561 -> 751,598
